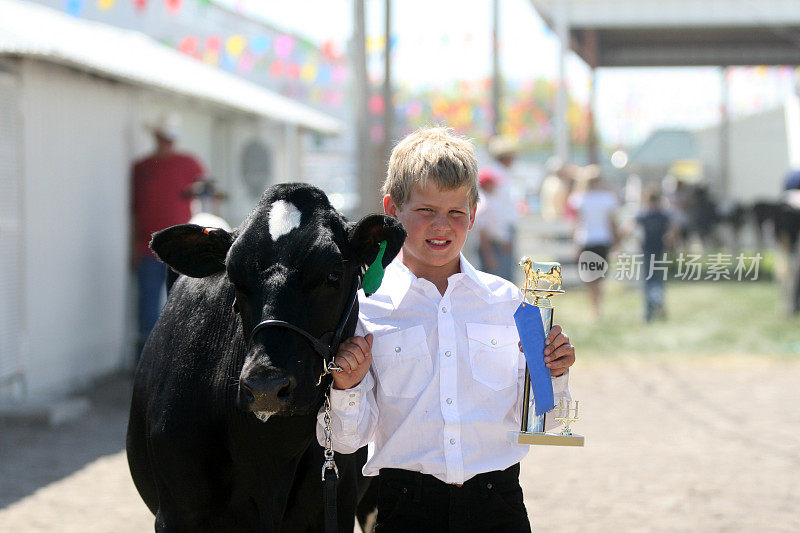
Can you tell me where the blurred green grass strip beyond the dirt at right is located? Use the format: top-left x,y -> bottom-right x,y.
554,280 -> 800,360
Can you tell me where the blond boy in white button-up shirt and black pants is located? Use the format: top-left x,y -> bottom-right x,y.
317,128 -> 575,532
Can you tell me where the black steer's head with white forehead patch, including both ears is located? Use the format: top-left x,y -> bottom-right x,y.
151,184 -> 405,421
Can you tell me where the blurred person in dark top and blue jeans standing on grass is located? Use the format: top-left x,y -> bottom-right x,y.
636,186 -> 678,322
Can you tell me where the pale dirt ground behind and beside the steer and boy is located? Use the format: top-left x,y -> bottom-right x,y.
0,357 -> 800,533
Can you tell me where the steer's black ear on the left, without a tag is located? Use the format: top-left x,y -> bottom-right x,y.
150,224 -> 233,278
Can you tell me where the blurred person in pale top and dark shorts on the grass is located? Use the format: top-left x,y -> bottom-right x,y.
567,165 -> 619,320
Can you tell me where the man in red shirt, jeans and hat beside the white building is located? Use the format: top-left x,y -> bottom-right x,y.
132,114 -> 204,348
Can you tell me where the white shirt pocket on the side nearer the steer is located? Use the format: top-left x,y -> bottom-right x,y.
372,326 -> 433,398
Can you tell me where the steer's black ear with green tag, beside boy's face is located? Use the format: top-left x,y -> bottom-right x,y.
348,215 -> 406,267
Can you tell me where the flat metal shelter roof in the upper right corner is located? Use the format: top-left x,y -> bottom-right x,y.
530,0 -> 800,67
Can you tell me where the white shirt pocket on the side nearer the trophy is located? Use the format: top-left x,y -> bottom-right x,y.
467,323 -> 520,391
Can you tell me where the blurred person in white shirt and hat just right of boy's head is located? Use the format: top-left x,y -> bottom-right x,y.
475,137 -> 518,280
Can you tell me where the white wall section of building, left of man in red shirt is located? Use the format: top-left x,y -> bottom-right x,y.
22,61 -> 134,396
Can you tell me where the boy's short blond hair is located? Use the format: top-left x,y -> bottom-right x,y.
382,127 -> 478,207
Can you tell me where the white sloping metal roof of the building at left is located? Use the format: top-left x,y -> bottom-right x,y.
0,0 -> 343,134
